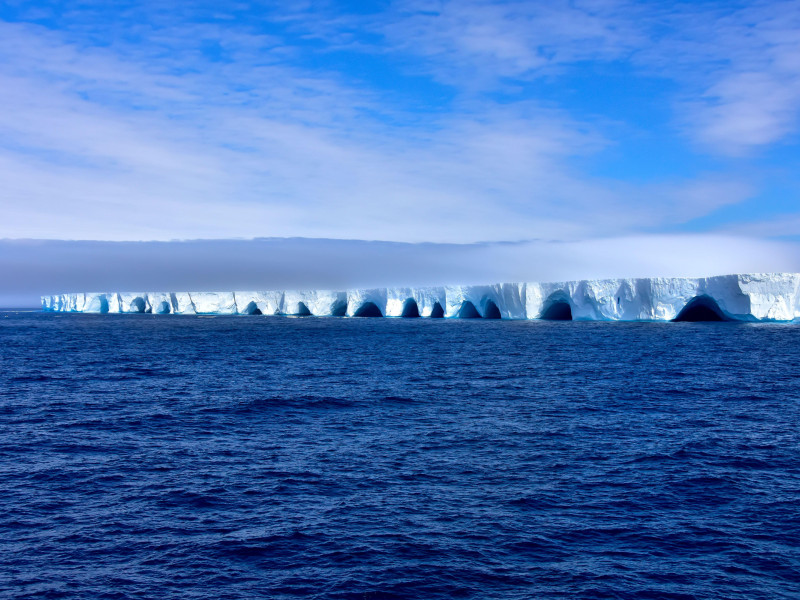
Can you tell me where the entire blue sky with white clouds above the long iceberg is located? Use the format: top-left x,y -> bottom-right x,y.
0,0 -> 800,304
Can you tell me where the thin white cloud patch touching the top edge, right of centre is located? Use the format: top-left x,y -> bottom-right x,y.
376,0 -> 641,86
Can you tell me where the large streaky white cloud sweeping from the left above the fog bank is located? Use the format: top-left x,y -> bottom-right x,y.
0,15 -> 756,241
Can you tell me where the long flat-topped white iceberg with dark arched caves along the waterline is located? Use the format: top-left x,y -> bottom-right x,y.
42,273 -> 800,322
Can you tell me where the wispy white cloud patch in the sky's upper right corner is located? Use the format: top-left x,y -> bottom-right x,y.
643,0 -> 800,156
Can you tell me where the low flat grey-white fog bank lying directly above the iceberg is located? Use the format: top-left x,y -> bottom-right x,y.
0,235 -> 800,307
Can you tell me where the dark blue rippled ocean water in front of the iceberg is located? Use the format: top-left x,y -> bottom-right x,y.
0,312 -> 800,600
